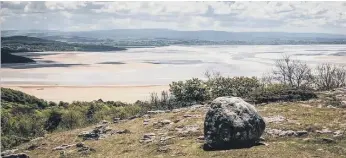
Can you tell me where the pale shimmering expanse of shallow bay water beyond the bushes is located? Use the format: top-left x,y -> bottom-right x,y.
1,45 -> 346,85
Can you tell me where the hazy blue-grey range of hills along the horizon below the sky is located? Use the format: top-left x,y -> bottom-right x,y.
2,29 -> 346,45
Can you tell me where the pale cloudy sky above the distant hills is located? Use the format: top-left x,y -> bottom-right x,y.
1,1 -> 346,34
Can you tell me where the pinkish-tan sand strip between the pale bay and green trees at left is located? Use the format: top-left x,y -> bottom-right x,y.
1,85 -> 169,103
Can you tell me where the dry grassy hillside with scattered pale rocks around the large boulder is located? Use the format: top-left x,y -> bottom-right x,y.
2,88 -> 346,158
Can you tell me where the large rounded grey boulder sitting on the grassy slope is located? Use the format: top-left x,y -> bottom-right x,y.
204,97 -> 265,150
